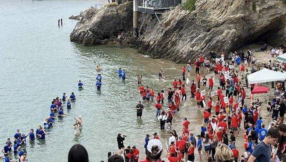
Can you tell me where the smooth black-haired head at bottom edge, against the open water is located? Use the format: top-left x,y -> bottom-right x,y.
68,144 -> 89,162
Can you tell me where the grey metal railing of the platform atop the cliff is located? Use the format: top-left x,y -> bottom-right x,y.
139,0 -> 181,8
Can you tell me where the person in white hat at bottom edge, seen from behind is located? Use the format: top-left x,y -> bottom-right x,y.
141,139 -> 163,162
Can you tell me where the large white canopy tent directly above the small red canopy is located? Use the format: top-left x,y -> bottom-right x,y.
247,68 -> 286,84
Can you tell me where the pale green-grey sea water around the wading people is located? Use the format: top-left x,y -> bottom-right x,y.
0,0 -> 185,162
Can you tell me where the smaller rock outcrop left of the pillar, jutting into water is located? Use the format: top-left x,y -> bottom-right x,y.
70,2 -> 132,45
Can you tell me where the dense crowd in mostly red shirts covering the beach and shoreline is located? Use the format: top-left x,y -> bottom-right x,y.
103,50 -> 286,162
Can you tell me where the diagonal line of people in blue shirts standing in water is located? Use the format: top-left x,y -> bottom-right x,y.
2,92 -> 76,162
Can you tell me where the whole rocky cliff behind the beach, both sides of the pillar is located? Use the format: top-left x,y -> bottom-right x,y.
71,0 -> 286,62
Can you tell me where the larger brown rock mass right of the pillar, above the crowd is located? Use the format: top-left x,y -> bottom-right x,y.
139,0 -> 286,62
